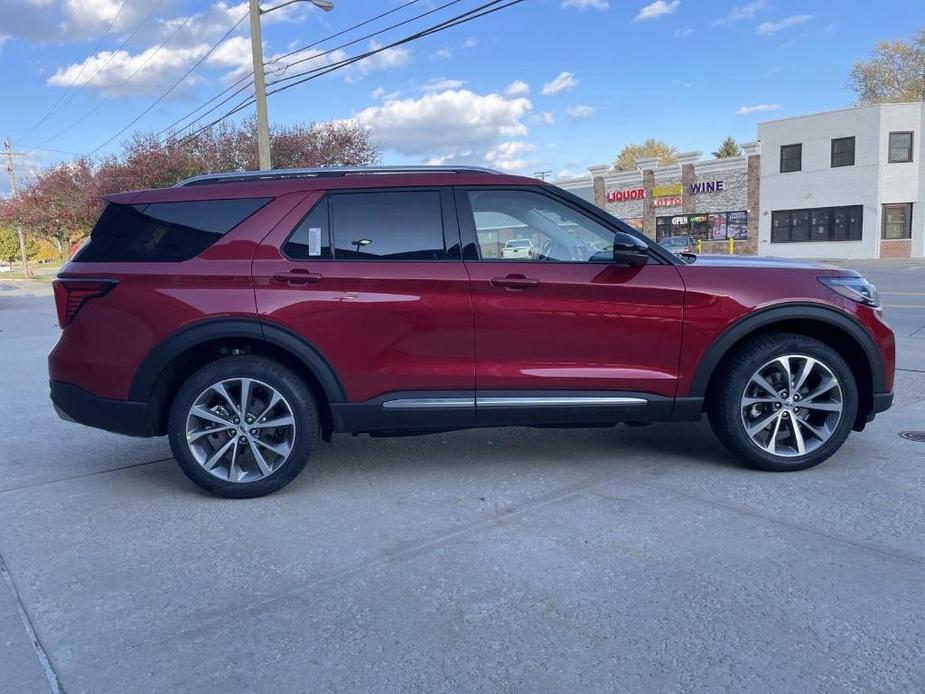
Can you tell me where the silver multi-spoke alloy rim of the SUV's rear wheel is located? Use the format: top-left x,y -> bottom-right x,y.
186,378 -> 296,482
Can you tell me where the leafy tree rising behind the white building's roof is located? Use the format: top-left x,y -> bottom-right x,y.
848,29 -> 925,106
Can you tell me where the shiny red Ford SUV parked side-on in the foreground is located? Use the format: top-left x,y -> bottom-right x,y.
49,167 -> 894,497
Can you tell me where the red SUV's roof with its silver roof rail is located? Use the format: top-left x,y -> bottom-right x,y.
104,167 -> 542,204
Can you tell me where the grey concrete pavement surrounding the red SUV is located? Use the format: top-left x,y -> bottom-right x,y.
0,272 -> 925,694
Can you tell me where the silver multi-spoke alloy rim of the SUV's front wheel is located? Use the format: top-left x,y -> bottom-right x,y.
740,354 -> 844,458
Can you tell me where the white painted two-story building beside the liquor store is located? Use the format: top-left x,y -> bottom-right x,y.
758,103 -> 925,258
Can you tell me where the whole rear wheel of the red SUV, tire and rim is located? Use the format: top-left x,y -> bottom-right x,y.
167,356 -> 319,499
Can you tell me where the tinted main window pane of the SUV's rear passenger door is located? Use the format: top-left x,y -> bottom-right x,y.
328,191 -> 447,260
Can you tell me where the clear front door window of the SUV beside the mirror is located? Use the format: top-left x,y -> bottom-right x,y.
467,190 -> 614,262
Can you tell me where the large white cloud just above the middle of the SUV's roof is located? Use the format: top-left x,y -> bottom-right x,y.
342,89 -> 532,163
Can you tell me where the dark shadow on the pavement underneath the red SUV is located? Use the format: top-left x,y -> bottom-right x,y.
142,422 -> 744,496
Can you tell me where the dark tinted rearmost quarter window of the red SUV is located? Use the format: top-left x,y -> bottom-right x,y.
74,198 -> 270,262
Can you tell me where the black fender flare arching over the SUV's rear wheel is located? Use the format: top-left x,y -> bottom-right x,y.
129,318 -> 345,402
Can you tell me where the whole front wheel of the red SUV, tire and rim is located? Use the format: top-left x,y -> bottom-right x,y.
708,333 -> 858,472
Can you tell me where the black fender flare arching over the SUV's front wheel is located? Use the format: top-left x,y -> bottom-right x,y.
689,303 -> 886,397
